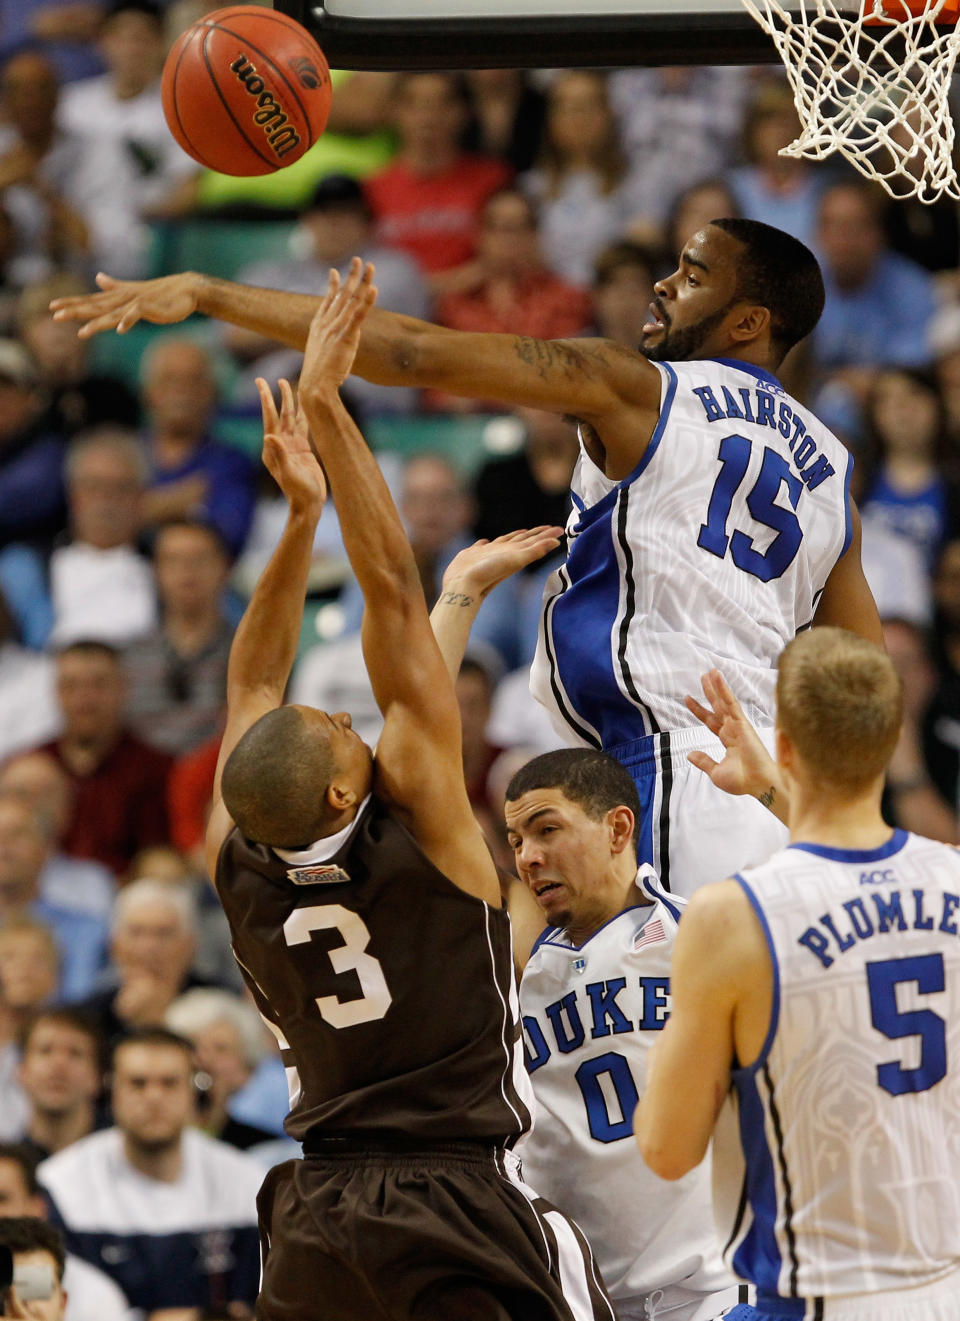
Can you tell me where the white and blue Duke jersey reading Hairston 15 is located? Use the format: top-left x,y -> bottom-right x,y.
531,359 -> 852,752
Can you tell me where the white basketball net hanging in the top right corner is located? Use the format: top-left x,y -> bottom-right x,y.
742,0 -> 960,202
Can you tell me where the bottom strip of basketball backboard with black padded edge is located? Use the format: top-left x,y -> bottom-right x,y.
273,0 -> 803,70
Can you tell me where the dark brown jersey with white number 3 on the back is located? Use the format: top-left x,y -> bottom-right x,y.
215,797 -> 532,1145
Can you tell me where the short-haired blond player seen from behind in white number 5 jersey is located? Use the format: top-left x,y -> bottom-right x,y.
636,629 -> 960,1321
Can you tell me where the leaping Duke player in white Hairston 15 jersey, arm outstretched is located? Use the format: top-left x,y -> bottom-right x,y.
51,219 -> 881,894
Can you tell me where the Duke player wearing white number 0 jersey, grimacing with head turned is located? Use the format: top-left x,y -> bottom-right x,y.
506,748 -> 750,1321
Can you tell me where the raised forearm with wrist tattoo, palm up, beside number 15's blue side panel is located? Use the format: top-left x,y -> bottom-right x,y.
430,524 -> 564,679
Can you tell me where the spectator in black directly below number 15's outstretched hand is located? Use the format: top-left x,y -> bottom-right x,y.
15,271 -> 140,436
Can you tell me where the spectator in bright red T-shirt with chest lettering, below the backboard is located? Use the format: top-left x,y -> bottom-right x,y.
366,73 -> 511,293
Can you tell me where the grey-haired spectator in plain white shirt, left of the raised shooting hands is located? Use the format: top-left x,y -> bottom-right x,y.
50,427 -> 157,647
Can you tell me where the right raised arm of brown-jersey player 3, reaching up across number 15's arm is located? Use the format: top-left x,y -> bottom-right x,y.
300,260 -> 500,905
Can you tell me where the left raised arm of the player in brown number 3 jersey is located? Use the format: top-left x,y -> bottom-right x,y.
206,380 -> 326,876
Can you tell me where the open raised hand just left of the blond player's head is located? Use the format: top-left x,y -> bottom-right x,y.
684,670 -> 790,826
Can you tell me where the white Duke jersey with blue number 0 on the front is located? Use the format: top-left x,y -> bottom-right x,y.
516,867 -> 734,1316
